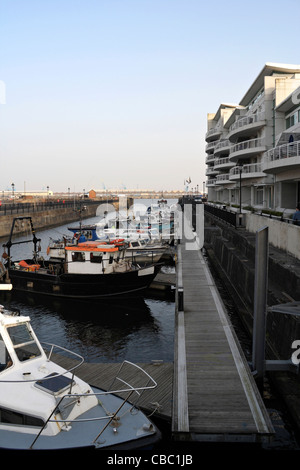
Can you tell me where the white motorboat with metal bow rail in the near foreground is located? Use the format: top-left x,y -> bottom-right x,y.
0,306 -> 160,451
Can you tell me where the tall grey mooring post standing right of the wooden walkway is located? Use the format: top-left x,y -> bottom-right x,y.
252,227 -> 269,382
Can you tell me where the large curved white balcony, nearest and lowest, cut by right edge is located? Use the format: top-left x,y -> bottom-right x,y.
262,141 -> 300,174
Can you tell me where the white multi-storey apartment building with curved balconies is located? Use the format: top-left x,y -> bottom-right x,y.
205,63 -> 300,214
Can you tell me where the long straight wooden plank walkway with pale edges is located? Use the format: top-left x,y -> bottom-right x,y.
172,218 -> 273,442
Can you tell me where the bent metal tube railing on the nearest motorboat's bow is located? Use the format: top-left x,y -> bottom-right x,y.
30,361 -> 157,449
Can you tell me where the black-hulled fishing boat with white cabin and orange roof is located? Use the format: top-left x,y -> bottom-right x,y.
2,217 -> 161,299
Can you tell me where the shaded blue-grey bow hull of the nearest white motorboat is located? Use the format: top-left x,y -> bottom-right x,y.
0,387 -> 161,452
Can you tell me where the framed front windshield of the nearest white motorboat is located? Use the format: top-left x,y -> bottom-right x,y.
7,323 -> 41,362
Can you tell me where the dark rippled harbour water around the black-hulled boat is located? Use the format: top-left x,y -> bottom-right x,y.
0,218 -> 175,362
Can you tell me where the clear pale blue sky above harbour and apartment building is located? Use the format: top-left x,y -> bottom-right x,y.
0,0 -> 300,192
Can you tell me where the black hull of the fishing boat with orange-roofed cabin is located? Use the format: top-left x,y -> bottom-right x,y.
8,265 -> 160,299
